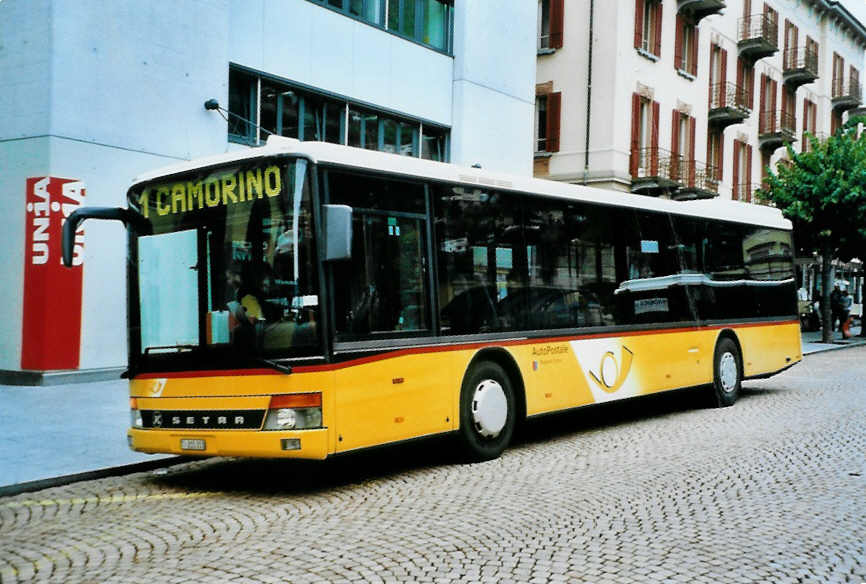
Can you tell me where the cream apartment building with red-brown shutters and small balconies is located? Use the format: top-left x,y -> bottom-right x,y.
534,0 -> 866,202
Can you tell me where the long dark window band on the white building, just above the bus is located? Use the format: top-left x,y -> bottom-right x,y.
228,67 -> 450,162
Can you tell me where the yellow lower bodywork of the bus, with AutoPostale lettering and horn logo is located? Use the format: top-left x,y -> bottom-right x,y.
121,322 -> 802,459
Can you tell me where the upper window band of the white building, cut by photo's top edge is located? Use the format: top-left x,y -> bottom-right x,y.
309,0 -> 454,52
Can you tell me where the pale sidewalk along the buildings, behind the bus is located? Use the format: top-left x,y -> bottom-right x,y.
0,327 -> 866,496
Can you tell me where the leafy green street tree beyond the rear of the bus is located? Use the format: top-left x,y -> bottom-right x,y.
757,116 -> 866,343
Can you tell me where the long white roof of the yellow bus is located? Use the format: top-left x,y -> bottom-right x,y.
132,136 -> 791,229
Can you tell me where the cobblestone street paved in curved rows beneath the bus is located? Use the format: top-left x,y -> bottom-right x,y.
0,347 -> 866,584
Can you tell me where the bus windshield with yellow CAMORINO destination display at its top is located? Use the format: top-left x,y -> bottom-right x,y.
130,158 -> 321,367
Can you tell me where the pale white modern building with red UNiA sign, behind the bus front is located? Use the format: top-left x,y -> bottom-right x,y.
0,0 -> 536,382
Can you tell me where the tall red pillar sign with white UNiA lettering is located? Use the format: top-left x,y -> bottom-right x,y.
21,176 -> 85,371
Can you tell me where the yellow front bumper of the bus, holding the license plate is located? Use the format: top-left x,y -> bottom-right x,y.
127,428 -> 328,460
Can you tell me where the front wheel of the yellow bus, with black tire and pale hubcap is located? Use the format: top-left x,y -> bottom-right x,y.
459,361 -> 516,462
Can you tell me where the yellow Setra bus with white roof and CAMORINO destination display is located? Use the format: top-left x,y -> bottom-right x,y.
64,137 -> 802,460
